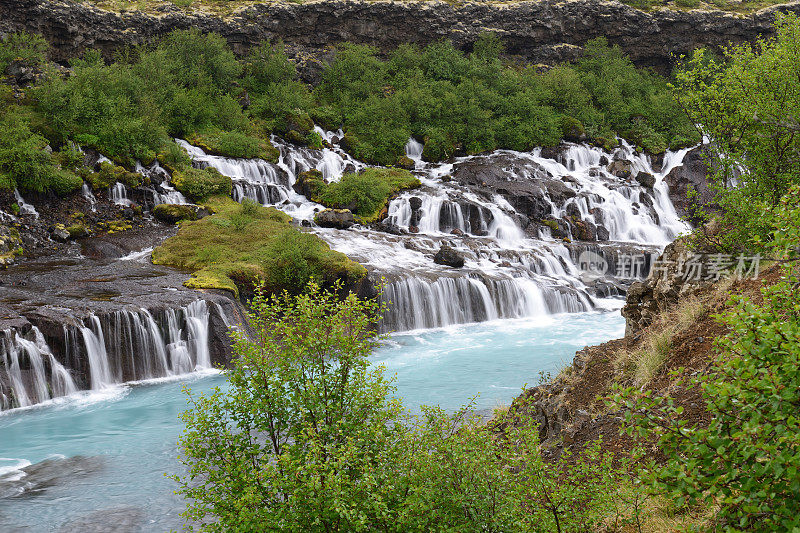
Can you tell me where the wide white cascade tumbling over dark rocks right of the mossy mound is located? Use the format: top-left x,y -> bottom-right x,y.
170,132 -> 688,330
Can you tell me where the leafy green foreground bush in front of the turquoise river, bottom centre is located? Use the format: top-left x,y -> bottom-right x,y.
175,280 -> 618,533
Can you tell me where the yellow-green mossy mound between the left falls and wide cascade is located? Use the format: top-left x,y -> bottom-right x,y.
153,196 -> 367,296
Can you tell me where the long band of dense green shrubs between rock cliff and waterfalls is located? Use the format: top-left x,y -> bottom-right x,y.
0,25 -> 698,194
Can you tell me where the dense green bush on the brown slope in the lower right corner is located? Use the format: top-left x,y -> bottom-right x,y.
617,187 -> 800,531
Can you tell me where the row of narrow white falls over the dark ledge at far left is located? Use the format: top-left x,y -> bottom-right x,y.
0,300 -> 212,409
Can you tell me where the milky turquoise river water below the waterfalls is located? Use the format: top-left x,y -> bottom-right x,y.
0,313 -> 624,532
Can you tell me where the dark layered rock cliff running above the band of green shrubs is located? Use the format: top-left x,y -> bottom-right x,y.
0,0 -> 800,80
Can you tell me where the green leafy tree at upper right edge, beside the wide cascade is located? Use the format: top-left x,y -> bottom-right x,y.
676,14 -> 800,249
